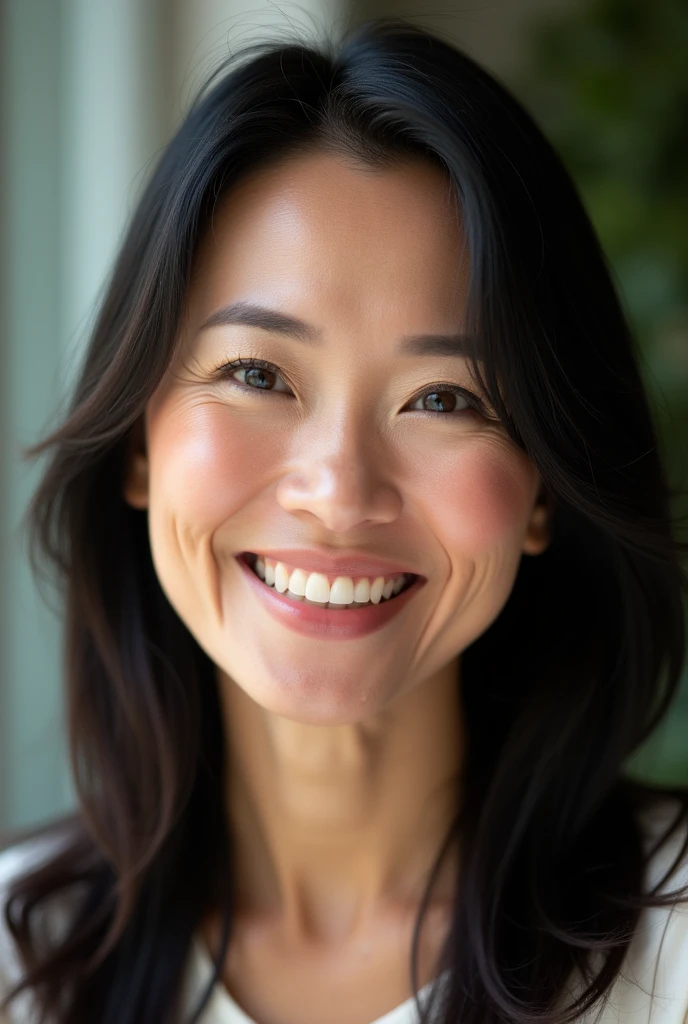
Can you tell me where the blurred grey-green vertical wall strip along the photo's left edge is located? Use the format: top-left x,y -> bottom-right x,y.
0,0 -> 68,826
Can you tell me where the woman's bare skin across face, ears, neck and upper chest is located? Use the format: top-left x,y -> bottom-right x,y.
125,153 -> 550,1024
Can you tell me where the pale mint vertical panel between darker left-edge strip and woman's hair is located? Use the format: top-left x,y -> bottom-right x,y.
60,0 -> 170,381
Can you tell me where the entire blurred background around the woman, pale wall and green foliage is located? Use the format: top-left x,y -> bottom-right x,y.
0,0 -> 688,831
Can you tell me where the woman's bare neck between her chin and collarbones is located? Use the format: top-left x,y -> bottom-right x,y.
219,660 -> 462,941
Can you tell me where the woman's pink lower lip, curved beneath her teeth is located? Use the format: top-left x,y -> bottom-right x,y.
235,555 -> 426,640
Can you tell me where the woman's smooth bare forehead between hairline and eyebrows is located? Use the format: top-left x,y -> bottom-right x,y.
189,154 -> 468,331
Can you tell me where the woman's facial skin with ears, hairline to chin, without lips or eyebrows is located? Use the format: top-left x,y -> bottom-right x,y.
125,154 -> 547,724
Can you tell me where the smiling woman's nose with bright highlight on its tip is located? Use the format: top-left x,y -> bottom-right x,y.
276,411 -> 402,534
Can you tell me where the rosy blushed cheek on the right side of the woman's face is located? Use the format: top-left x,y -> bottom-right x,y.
426,439 -> 533,556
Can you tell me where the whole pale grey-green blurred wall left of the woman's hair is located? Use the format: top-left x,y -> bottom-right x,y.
0,0 -> 167,830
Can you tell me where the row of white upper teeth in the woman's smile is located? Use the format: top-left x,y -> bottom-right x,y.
254,555 -> 406,605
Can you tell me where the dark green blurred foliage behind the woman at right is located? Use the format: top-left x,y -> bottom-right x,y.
510,0 -> 688,783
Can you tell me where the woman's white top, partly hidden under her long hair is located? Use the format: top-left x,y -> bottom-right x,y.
0,801 -> 688,1024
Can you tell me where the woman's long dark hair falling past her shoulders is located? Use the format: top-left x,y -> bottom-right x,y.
1,18 -> 688,1024
